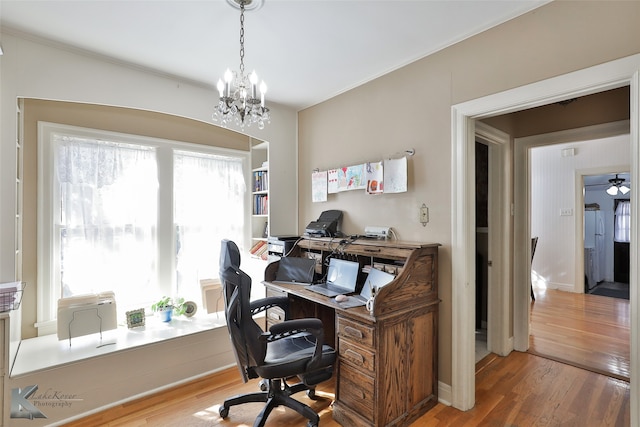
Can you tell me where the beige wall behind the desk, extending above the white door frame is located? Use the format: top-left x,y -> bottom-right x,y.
298,1 -> 640,384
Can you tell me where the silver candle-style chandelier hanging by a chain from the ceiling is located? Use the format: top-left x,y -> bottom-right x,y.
213,0 -> 271,129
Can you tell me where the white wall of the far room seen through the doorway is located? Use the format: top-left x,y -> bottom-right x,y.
530,135 -> 630,291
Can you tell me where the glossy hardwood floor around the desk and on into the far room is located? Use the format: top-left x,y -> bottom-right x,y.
67,291 -> 630,427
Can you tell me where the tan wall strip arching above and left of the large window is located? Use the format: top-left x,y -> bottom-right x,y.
21,99 -> 249,339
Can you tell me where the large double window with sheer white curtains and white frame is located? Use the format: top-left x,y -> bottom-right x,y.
38,123 -> 248,332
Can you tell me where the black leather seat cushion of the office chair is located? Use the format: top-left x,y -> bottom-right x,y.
254,333 -> 336,385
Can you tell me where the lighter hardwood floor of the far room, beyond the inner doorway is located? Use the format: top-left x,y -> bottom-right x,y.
529,290 -> 631,381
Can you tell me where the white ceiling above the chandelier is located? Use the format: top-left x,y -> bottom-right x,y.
0,0 -> 549,110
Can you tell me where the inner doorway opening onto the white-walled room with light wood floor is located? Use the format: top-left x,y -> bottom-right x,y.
515,131 -> 630,381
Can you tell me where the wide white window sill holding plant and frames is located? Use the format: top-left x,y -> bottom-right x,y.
10,313 -> 226,378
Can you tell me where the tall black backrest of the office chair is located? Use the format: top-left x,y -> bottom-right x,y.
220,239 -> 267,382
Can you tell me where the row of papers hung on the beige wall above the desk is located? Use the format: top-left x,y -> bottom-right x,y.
311,150 -> 413,203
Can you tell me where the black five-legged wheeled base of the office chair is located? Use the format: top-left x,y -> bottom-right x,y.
218,379 -> 320,427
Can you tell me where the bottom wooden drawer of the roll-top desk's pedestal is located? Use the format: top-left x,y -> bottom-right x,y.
338,362 -> 375,423
